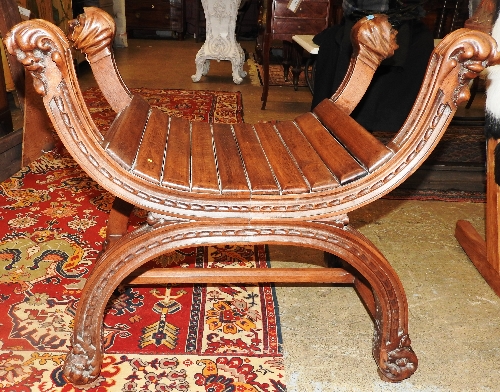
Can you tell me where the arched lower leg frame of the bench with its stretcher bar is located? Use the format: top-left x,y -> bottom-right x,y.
64,217 -> 418,384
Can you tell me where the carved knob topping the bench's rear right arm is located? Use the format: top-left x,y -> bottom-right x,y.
351,14 -> 398,70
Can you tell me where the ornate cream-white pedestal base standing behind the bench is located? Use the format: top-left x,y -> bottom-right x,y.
191,0 -> 247,84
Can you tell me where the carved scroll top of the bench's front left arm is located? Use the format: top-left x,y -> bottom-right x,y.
4,19 -> 71,100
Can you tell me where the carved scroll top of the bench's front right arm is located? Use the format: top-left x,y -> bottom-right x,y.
434,29 -> 500,105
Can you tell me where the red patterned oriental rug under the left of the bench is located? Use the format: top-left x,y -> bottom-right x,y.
0,89 -> 286,392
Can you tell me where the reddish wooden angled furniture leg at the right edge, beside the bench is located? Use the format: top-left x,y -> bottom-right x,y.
455,138 -> 500,296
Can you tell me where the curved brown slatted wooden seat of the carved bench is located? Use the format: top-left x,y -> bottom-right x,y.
106,95 -> 393,197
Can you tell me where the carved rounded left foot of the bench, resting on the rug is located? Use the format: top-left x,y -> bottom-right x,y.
63,350 -> 102,385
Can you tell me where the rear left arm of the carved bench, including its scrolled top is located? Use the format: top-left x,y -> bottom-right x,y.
68,7 -> 132,113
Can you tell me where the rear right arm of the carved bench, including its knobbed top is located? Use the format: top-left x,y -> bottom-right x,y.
331,15 -> 398,114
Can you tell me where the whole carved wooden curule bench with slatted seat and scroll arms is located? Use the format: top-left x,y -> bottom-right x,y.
5,8 -> 500,384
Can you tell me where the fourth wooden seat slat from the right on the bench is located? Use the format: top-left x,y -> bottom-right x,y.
254,123 -> 310,194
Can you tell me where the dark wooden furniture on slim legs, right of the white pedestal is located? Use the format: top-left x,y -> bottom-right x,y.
256,0 -> 332,109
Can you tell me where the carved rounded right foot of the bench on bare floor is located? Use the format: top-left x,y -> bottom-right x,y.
379,335 -> 418,382
